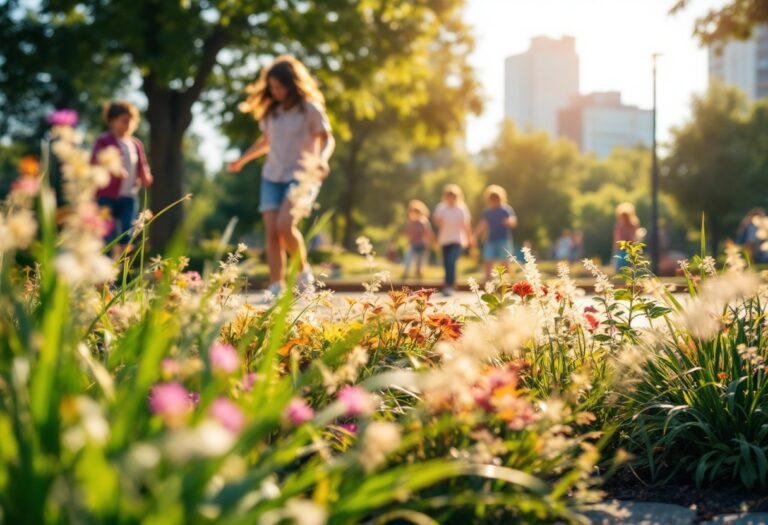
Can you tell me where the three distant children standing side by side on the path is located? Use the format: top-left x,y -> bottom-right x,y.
403,184 -> 517,296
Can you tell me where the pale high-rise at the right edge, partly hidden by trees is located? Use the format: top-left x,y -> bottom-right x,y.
709,25 -> 768,101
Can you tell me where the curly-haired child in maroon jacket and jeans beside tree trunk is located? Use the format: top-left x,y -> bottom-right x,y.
91,100 -> 152,257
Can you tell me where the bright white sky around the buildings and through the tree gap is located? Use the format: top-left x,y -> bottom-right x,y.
193,0 -> 726,171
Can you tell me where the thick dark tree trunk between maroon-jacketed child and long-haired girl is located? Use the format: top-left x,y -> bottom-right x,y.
144,81 -> 192,251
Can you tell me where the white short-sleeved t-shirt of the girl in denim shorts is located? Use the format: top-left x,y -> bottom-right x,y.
259,101 -> 331,182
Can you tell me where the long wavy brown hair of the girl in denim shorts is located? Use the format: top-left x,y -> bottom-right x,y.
240,55 -> 325,120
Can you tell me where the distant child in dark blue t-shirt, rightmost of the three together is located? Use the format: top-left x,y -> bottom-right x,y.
475,184 -> 517,280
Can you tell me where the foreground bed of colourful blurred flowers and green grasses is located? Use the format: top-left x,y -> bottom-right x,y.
0,122 -> 768,524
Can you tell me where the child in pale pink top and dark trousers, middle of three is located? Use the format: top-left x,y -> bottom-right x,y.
433,184 -> 474,297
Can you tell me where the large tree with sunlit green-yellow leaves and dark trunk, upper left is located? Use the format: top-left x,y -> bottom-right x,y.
0,0 -> 476,250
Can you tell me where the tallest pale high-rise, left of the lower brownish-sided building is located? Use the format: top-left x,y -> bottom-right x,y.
504,36 -> 579,137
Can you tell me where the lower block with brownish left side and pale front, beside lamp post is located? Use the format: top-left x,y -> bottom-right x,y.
558,91 -> 653,159
